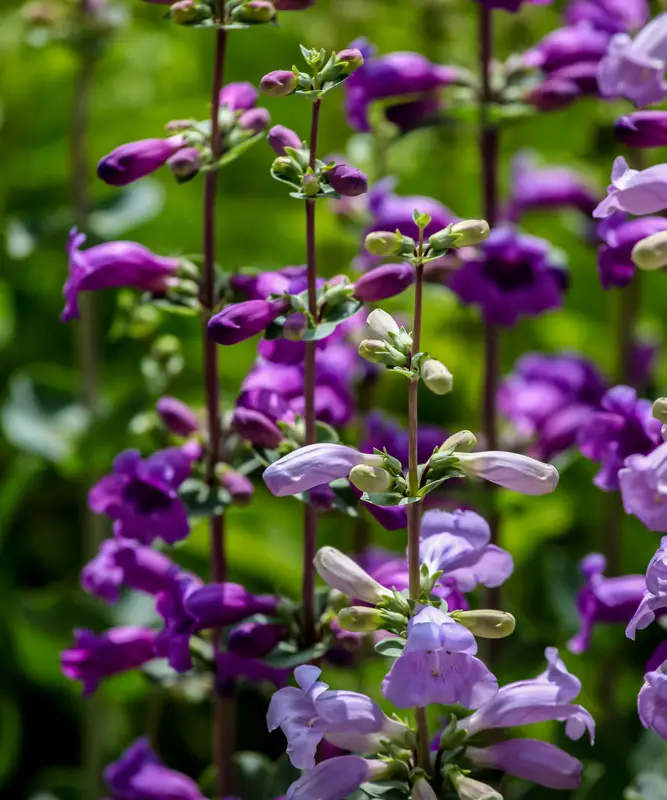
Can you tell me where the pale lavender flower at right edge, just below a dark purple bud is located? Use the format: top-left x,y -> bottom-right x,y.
593,155 -> 667,219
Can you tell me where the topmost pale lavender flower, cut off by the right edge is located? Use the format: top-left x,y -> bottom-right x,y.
598,14 -> 667,108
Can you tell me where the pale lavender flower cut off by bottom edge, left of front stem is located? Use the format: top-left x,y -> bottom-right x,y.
285,756 -> 389,800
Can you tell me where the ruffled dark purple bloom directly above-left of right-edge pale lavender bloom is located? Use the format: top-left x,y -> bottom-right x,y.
498,353 -> 606,461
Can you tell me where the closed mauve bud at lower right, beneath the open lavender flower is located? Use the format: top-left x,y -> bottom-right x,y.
466,739 -> 583,789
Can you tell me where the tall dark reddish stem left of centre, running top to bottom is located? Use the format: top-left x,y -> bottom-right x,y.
201,29 -> 236,798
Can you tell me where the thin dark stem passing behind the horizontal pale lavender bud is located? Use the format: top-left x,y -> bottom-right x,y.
301,99 -> 322,644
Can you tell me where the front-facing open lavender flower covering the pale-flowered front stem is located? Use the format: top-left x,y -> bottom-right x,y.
382,606 -> 498,708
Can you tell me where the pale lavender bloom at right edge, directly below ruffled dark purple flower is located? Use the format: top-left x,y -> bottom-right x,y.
618,442 -> 667,533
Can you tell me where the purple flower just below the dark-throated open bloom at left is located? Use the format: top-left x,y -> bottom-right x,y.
81,539 -> 179,603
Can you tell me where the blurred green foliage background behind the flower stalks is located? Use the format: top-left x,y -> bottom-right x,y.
0,0 -> 667,800
